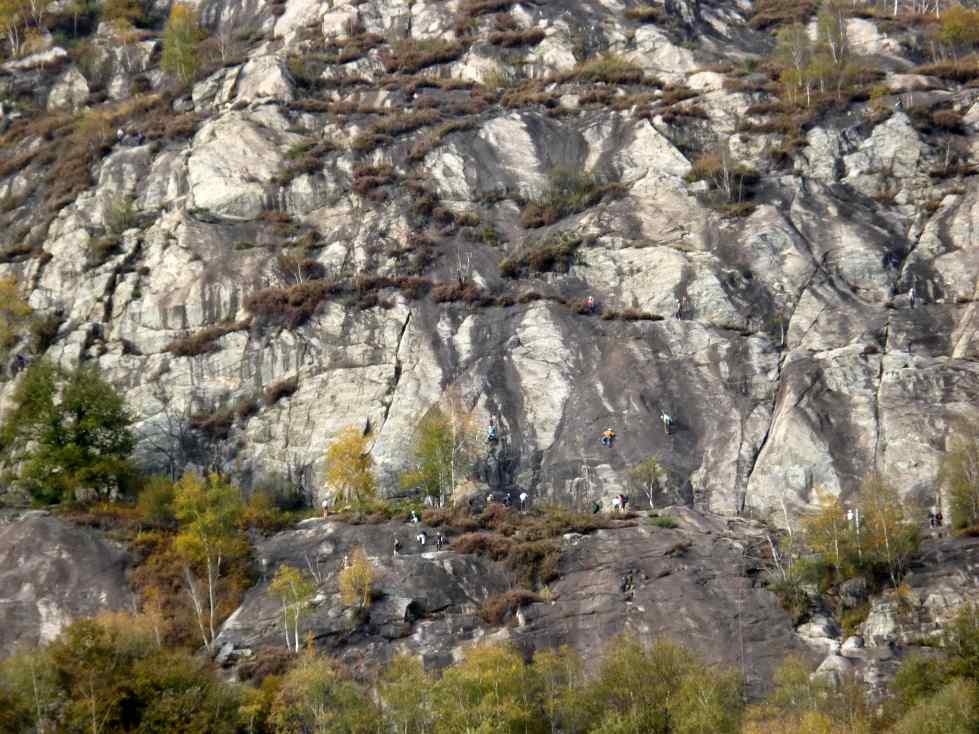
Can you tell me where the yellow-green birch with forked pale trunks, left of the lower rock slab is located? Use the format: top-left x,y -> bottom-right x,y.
174,474 -> 248,650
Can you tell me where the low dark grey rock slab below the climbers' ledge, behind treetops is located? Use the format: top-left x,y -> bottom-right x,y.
209,508 -> 816,692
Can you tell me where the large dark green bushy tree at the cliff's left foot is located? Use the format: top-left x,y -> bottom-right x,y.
2,361 -> 134,503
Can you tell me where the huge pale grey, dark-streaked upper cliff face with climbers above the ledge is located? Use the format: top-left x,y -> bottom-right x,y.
0,0 -> 979,521
